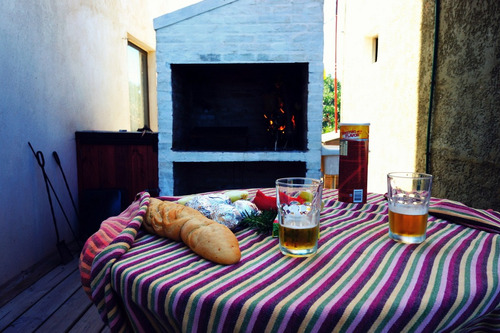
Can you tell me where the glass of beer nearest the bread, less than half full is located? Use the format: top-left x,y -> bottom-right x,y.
276,177 -> 323,257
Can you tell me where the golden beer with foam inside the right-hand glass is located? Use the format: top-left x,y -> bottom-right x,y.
389,204 -> 428,243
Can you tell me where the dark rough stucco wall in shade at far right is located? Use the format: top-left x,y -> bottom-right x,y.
430,0 -> 500,210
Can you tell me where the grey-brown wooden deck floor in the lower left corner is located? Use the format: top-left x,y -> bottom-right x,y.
0,258 -> 109,333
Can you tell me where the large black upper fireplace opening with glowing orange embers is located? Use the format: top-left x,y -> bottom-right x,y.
171,63 -> 309,151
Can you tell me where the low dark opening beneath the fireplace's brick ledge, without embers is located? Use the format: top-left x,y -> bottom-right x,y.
173,162 -> 306,195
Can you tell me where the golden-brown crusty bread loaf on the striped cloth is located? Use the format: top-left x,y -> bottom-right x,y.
143,198 -> 241,265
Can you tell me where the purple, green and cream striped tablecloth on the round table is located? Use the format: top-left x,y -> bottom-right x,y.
80,189 -> 500,332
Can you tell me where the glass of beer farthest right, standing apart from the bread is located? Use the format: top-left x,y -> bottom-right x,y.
387,172 -> 432,244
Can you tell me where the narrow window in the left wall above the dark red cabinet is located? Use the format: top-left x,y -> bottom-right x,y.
127,43 -> 149,131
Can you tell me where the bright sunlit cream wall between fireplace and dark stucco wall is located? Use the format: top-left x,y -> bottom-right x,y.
341,0 -> 425,193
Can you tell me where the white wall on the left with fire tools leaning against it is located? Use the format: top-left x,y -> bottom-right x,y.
0,0 -> 188,285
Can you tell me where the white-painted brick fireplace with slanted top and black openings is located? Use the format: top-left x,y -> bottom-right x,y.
155,0 -> 323,195
